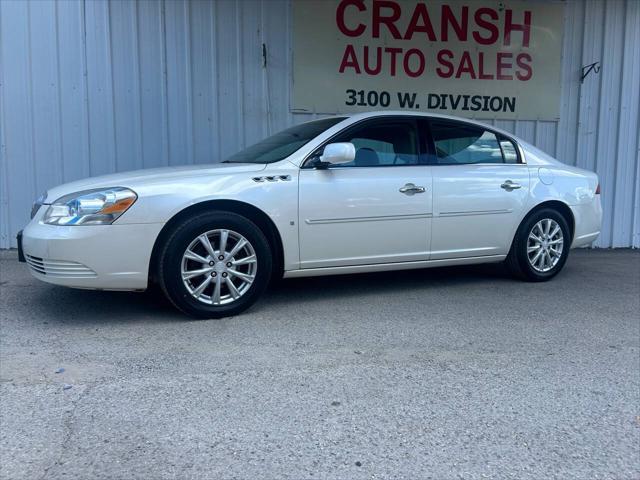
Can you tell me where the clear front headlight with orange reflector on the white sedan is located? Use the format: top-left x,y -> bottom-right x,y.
42,187 -> 138,225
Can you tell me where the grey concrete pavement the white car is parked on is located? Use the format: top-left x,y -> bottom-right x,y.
0,250 -> 640,480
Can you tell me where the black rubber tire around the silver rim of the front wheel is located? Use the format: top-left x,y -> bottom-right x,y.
158,211 -> 273,319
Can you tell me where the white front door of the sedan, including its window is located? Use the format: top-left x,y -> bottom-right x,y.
298,118 -> 432,268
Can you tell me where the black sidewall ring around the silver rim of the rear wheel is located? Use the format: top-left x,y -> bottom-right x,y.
515,208 -> 572,282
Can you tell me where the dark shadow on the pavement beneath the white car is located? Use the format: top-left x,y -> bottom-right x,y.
29,264 -> 513,324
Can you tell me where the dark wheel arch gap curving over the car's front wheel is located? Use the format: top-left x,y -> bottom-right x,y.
149,200 -> 284,284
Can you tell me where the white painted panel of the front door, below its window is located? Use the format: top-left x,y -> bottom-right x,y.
298,166 -> 433,269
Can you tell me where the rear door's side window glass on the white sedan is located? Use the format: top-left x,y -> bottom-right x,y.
431,122 -> 518,165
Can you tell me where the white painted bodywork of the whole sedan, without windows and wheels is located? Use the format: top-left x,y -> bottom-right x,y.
22,112 -> 602,290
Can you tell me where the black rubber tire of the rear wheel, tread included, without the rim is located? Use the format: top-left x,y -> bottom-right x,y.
505,208 -> 572,282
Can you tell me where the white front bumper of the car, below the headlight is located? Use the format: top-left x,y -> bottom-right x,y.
18,208 -> 164,290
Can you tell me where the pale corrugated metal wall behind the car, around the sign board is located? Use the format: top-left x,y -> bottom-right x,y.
0,0 -> 640,248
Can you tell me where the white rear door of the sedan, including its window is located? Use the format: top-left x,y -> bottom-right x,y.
429,120 -> 529,260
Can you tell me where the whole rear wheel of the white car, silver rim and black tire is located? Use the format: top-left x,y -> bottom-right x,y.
506,208 -> 571,282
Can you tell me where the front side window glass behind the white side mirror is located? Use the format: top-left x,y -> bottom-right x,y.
331,121 -> 419,167
